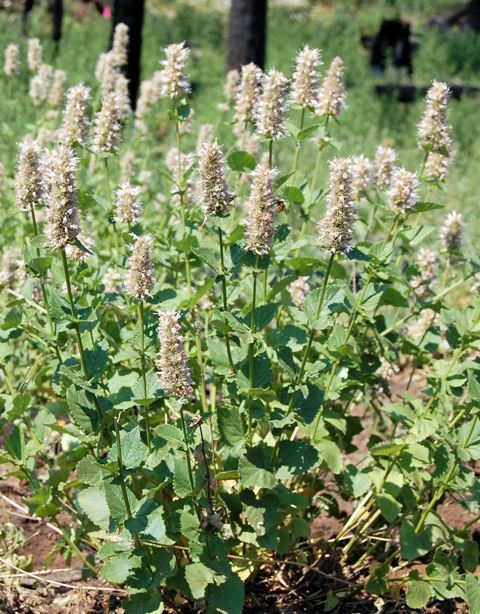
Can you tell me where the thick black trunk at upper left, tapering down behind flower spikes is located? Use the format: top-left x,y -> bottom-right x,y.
112,0 -> 145,109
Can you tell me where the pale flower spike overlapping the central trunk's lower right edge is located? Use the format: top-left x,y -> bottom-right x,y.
255,68 -> 288,140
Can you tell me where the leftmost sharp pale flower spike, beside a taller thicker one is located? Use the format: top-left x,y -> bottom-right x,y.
15,138 -> 44,211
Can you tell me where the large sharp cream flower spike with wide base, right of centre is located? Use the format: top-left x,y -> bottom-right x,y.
318,158 -> 355,254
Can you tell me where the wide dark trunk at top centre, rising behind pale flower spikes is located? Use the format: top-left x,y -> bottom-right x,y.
227,0 -> 267,70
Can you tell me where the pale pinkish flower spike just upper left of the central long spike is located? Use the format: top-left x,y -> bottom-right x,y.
198,141 -> 234,216
